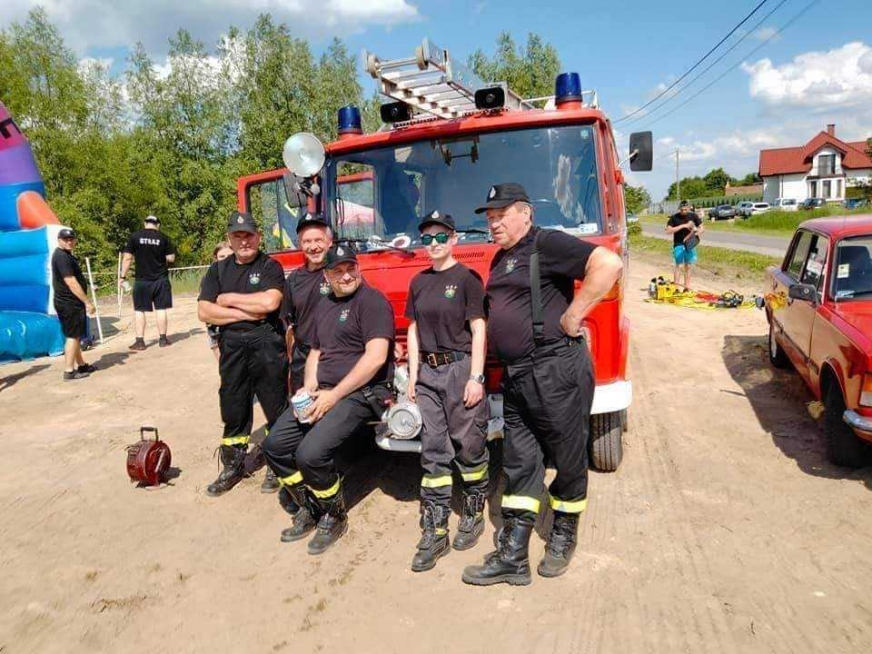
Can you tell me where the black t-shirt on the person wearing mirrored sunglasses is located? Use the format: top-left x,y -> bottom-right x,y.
406,263 -> 484,353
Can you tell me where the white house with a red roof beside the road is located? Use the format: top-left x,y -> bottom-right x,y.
759,125 -> 872,204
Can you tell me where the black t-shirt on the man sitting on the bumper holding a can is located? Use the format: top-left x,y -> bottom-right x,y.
312,286 -> 394,388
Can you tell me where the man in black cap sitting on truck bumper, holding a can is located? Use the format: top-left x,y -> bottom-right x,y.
263,246 -> 394,554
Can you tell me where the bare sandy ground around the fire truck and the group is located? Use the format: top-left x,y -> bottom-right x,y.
0,262 -> 872,654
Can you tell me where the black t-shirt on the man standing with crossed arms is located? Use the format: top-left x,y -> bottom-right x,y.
198,252 -> 285,331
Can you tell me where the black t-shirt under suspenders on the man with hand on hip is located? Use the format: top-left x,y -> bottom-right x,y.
487,228 -> 596,362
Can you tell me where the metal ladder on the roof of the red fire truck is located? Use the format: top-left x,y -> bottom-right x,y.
363,38 -> 534,118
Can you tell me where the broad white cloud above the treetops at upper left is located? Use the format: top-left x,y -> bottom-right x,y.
0,0 -> 420,52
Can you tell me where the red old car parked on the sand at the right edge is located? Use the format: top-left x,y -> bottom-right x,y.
762,216 -> 872,466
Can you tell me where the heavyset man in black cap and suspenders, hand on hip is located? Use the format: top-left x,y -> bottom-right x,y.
463,183 -> 623,586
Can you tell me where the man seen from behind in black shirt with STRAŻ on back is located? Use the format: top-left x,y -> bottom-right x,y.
118,216 -> 176,350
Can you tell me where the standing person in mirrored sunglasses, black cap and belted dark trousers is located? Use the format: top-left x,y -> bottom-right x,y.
406,211 -> 488,572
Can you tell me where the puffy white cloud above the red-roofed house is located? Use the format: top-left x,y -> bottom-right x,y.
742,42 -> 872,112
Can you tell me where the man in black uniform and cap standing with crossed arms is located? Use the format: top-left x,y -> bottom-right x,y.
197,212 -> 288,497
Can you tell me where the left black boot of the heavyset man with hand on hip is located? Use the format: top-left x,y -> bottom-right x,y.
462,517 -> 533,586
